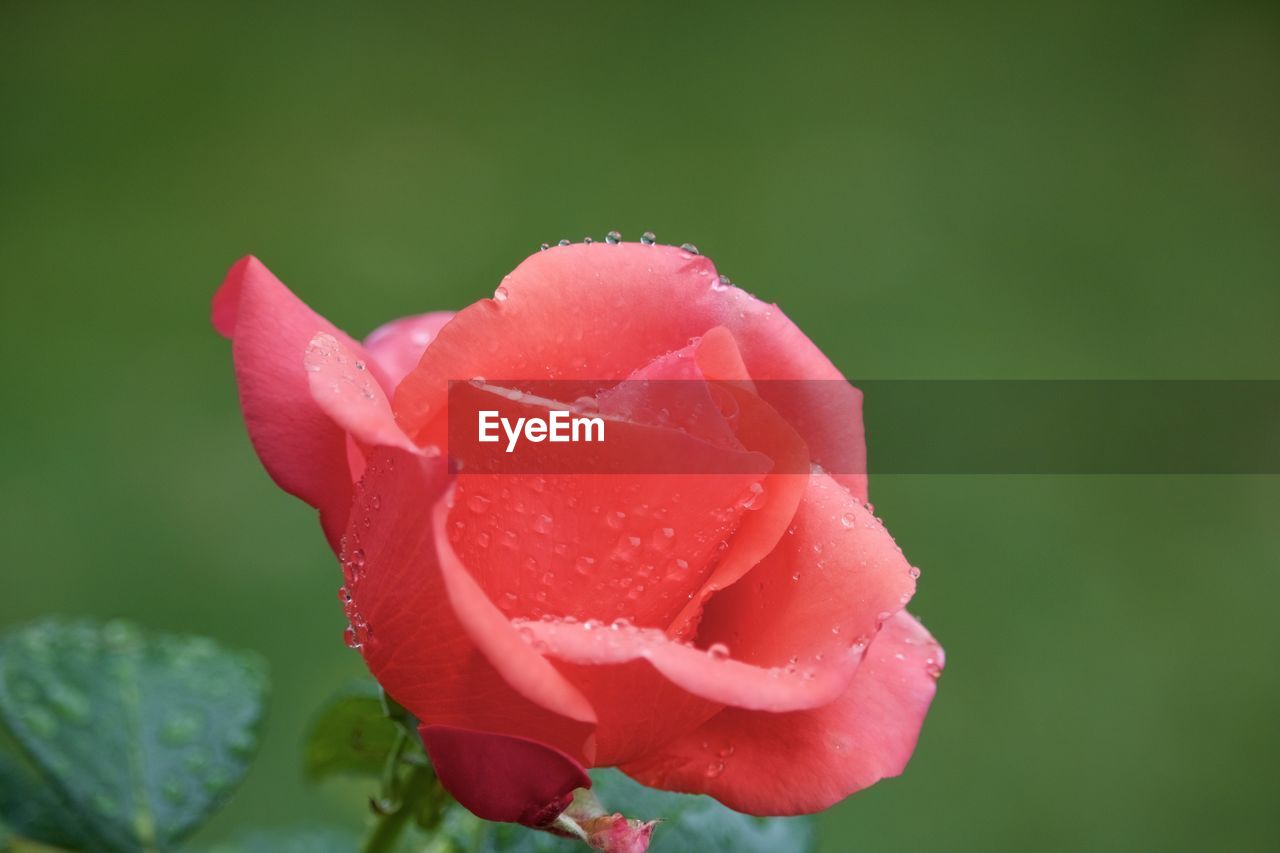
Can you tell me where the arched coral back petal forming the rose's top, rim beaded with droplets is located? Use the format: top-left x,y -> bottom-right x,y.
394,243 -> 867,498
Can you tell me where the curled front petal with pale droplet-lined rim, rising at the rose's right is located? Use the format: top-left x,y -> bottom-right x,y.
494,474 -> 915,763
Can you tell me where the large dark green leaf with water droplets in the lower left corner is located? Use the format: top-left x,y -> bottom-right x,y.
0,620 -> 266,850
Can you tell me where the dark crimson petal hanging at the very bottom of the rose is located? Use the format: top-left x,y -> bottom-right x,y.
420,726 -> 591,826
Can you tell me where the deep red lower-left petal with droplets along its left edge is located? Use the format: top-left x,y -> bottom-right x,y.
344,448 -> 595,763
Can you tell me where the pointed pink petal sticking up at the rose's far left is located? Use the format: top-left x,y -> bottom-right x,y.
212,256 -> 378,547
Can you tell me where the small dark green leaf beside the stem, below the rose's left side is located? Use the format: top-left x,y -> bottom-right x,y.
303,683 -> 401,779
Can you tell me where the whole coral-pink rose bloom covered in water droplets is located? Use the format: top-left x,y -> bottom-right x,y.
212,242 -> 942,826
